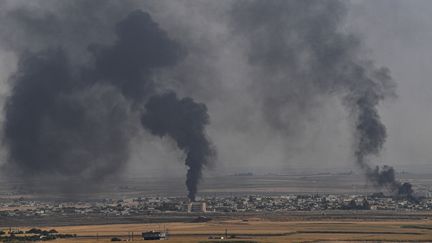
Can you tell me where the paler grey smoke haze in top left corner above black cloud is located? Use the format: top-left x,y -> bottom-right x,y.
0,0 -> 139,54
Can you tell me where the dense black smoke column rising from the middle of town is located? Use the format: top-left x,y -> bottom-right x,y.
141,93 -> 214,201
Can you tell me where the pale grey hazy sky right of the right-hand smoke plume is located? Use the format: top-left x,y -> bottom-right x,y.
347,0 -> 432,174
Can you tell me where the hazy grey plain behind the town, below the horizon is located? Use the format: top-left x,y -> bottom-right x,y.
0,173 -> 432,201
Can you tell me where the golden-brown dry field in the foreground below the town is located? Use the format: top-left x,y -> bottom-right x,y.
25,219 -> 432,243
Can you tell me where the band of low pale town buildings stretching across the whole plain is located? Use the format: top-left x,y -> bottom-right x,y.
0,194 -> 432,217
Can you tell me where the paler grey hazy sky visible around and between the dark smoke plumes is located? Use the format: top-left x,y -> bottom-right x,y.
0,0 -> 432,184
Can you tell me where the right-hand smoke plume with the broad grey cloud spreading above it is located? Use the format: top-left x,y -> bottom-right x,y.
231,0 -> 416,197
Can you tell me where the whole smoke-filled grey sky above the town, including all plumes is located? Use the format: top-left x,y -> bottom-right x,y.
0,0 -> 432,200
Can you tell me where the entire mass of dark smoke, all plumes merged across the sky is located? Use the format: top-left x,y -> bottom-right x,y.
0,0 -> 418,199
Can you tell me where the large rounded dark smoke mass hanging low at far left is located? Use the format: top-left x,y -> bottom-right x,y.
3,49 -> 128,190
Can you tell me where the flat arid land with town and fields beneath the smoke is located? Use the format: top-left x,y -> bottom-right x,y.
0,173 -> 432,243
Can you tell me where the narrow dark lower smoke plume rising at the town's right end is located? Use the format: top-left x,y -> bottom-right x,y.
352,71 -> 417,199
